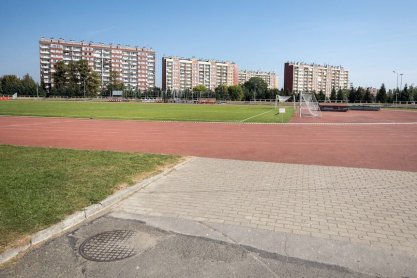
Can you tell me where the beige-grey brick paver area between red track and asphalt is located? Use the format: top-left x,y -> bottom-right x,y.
115,158 -> 417,252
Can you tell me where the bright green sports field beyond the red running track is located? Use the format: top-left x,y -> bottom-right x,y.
0,100 -> 293,123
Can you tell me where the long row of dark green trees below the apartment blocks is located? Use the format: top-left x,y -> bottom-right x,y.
0,67 -> 417,103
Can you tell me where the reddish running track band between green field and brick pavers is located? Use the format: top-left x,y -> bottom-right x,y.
0,114 -> 417,172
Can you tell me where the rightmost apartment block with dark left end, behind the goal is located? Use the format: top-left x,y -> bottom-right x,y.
284,62 -> 349,96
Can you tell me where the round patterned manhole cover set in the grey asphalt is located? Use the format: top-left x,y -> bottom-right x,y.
79,230 -> 136,262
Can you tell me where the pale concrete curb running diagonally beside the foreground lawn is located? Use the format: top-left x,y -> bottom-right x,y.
0,157 -> 194,265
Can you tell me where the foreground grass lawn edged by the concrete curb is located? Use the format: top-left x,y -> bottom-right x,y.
0,145 -> 180,252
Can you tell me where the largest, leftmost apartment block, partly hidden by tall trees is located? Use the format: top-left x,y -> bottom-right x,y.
39,38 -> 155,90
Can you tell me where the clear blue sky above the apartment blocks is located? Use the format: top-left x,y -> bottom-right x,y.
0,0 -> 417,88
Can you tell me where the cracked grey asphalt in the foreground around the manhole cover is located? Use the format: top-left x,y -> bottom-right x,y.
0,216 -> 369,278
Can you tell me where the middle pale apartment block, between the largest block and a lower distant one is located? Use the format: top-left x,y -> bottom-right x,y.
162,57 -> 238,91
